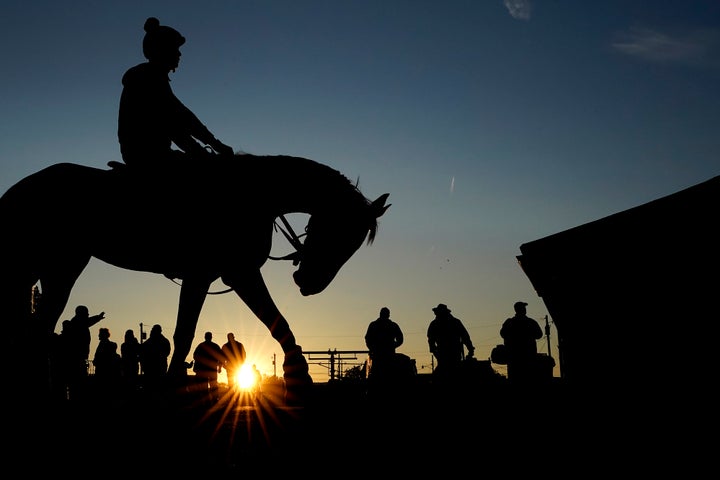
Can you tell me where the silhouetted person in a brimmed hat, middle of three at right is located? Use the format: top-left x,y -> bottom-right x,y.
427,303 -> 475,378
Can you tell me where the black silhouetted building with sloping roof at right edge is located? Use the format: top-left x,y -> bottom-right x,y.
517,172 -> 720,406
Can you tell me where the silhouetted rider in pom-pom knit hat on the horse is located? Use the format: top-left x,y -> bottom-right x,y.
118,17 -> 233,171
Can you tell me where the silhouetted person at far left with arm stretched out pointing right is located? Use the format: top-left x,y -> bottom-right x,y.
63,305 -> 105,400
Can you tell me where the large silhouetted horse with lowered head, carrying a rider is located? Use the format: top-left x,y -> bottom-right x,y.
0,154 -> 390,401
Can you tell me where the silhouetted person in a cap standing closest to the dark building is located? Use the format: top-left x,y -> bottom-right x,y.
500,302 -> 543,384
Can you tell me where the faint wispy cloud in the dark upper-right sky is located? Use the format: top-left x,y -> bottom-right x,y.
612,28 -> 720,66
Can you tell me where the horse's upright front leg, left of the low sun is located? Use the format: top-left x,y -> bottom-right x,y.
168,278 -> 212,381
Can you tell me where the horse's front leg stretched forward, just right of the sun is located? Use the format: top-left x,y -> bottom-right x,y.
222,269 -> 312,403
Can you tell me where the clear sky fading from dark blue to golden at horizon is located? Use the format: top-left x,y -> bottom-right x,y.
0,0 -> 720,381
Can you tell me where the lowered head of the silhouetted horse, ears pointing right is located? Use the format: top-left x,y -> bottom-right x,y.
293,193 -> 390,296
